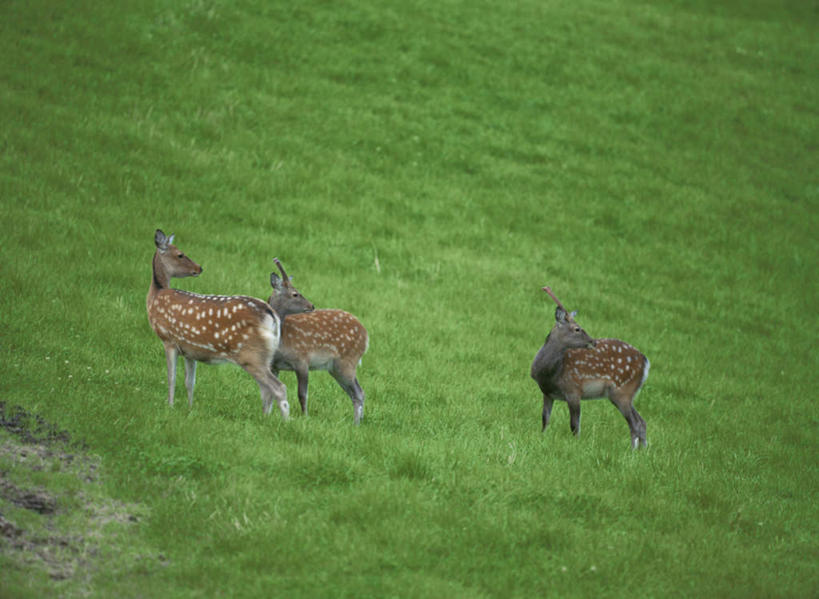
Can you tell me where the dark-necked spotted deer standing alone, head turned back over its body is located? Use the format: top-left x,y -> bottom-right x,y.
531,287 -> 650,449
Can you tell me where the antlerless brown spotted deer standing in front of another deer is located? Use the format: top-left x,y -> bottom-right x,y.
146,229 -> 290,420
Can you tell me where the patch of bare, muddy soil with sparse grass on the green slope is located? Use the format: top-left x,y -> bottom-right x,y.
0,402 -> 151,580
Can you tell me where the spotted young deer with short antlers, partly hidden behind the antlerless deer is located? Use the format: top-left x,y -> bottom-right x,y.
268,258 -> 370,425
